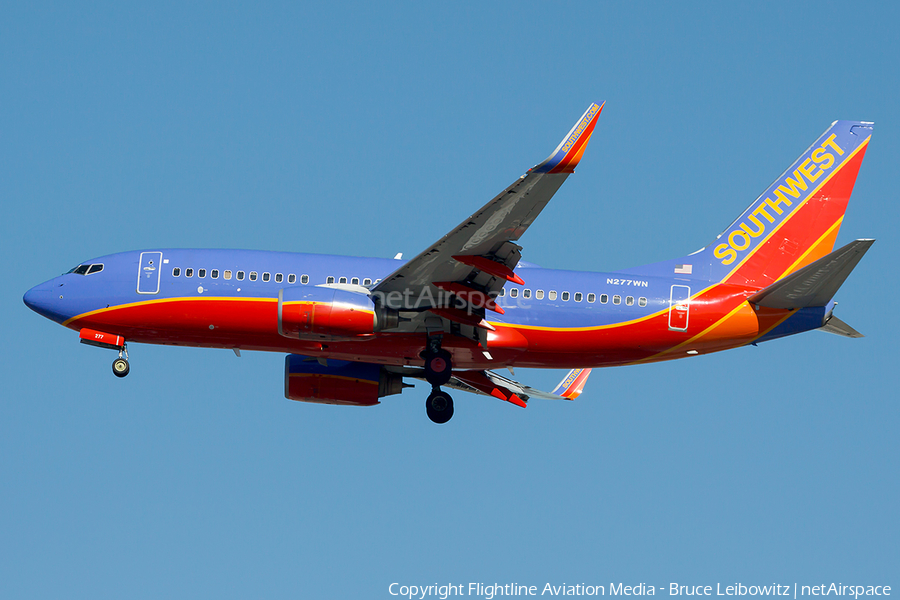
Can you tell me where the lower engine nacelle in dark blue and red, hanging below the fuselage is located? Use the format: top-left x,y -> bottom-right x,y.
284,354 -> 403,406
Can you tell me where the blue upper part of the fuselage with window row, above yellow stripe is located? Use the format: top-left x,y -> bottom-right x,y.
24,249 -> 708,327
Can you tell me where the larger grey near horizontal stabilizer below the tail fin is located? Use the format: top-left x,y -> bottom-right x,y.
747,240 -> 875,308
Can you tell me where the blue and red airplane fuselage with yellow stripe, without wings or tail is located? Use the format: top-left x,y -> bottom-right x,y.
26,249 -> 825,369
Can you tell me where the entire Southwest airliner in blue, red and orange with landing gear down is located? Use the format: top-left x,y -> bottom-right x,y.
24,104 -> 874,423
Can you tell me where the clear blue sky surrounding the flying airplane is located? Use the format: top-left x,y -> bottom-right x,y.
0,2 -> 900,598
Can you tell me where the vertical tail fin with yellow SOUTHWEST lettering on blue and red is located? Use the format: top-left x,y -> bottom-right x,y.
704,121 -> 873,287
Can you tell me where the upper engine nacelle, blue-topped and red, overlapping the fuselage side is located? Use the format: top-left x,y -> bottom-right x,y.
278,286 -> 399,338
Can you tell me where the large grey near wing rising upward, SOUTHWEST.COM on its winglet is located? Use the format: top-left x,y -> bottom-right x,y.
371,104 -> 602,318
